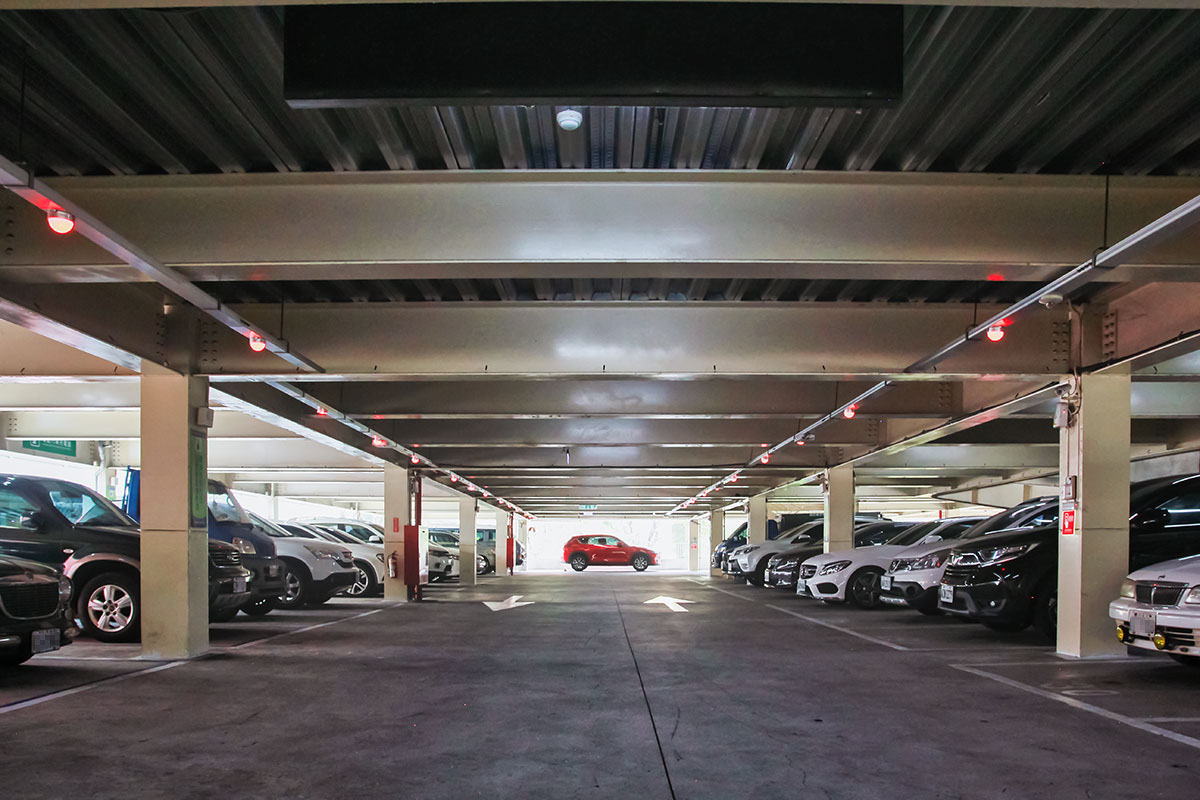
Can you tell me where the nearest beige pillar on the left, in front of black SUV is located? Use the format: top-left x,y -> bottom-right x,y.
140,361 -> 209,658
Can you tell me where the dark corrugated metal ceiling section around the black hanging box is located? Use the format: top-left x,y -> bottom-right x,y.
0,6 -> 1200,175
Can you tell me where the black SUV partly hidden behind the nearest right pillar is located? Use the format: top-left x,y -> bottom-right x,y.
937,475 -> 1200,638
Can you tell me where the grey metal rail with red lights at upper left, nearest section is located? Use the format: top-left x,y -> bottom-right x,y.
0,156 -> 324,373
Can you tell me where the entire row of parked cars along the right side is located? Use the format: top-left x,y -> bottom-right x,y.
722,475 -> 1200,667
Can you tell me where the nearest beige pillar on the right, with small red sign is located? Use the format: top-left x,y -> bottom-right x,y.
1065,372 -> 1129,657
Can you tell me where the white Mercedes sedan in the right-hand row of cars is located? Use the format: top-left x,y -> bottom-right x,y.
796,519 -> 941,608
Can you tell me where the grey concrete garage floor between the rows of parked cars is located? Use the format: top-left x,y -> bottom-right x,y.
0,572 -> 1200,800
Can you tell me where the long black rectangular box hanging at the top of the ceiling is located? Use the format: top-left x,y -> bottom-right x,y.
283,1 -> 904,108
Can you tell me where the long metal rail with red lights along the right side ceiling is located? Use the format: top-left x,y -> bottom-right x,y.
665,196 -> 1200,517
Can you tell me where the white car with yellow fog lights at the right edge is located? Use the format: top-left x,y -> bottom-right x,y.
1109,555 -> 1200,667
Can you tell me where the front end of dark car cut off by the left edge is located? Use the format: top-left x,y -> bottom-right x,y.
0,557 -> 79,667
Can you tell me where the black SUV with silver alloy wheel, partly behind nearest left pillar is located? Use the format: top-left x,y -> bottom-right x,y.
0,475 -> 251,642
